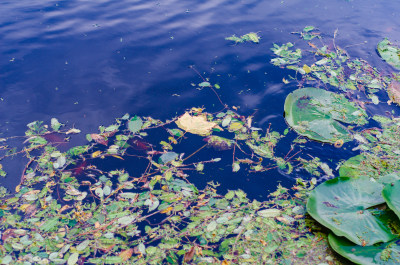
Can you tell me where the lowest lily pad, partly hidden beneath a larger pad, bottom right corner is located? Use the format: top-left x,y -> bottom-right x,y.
328,233 -> 400,265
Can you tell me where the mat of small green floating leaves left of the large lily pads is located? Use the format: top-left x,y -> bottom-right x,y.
0,108 -> 340,265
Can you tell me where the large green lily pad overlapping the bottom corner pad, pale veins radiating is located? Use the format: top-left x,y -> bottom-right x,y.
307,176 -> 395,246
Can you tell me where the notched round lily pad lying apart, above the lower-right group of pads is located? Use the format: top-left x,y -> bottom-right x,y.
285,87 -> 367,143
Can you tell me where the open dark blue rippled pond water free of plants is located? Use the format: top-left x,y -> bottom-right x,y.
0,0 -> 400,196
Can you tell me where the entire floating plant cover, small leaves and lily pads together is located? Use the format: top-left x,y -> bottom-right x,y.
0,26 -> 400,265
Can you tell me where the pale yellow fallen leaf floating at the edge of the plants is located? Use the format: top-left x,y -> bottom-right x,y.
176,112 -> 217,136
